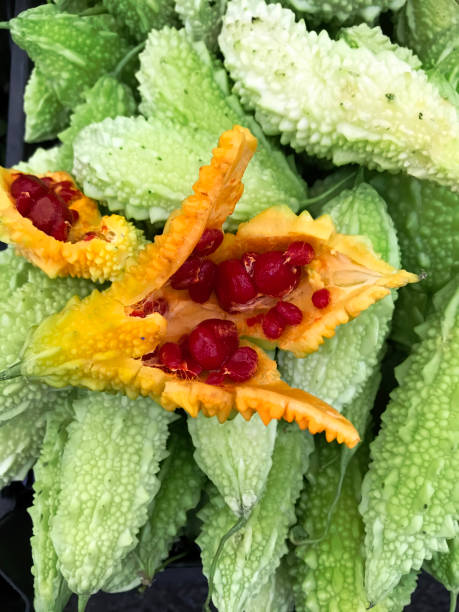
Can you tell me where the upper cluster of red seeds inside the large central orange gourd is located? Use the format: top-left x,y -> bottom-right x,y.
171,229 -> 330,339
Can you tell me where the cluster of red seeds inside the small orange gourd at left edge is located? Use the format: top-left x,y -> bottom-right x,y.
10,174 -> 81,242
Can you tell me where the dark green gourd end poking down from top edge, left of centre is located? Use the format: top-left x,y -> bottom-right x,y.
102,0 -> 178,41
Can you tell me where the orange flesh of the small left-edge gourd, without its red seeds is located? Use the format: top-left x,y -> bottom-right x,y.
0,168 -> 143,281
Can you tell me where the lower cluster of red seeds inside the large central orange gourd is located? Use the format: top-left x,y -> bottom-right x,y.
142,319 -> 258,385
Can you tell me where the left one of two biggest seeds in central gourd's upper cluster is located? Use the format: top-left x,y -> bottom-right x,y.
215,259 -> 257,312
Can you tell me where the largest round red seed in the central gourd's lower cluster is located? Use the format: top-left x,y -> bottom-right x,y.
188,319 -> 239,370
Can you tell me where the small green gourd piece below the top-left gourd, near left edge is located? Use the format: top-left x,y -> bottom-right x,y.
24,68 -> 70,143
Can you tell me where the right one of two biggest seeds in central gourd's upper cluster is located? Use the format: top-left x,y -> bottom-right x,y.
253,251 -> 301,297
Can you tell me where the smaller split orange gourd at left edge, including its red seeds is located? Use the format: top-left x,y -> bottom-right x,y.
0,168 -> 143,281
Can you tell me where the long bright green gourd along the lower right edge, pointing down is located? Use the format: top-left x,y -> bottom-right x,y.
360,279 -> 459,603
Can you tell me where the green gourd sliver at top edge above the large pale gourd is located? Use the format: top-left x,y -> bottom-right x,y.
274,0 -> 405,22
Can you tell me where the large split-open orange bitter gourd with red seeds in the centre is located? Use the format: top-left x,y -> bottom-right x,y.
15,126 -> 417,446
